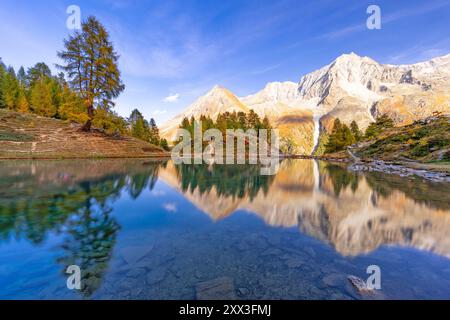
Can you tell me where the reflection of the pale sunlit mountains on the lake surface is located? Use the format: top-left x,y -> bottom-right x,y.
160,160 -> 450,257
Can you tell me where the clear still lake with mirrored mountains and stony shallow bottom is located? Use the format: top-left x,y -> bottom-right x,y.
0,160 -> 450,299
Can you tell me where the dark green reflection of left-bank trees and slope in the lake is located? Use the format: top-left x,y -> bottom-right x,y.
0,162 -> 164,297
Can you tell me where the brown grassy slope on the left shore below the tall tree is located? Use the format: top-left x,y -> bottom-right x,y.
0,110 -> 165,159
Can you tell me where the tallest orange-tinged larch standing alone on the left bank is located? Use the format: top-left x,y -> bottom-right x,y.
58,17 -> 125,131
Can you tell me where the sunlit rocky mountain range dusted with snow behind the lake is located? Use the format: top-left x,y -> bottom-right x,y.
162,53 -> 450,154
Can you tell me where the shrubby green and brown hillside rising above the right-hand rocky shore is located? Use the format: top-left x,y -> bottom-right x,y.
352,116 -> 450,162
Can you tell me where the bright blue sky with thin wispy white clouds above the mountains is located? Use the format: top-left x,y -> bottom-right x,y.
0,0 -> 450,124
